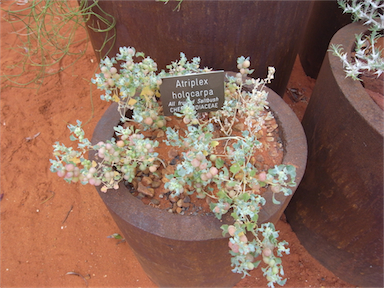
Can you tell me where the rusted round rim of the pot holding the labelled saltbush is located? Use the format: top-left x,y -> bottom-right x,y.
89,88 -> 307,241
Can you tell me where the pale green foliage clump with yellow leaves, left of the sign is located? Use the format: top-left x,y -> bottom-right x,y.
92,47 -> 210,129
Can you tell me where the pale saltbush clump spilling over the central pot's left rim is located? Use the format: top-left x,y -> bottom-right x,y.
50,121 -> 159,192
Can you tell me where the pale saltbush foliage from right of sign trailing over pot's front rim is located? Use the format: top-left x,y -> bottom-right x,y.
165,64 -> 296,287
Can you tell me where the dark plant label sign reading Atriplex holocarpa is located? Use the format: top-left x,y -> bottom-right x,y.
160,71 -> 224,116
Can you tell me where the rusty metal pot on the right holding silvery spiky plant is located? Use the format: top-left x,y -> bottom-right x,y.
286,23 -> 384,287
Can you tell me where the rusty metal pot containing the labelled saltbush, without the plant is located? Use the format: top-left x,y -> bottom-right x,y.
90,84 -> 307,287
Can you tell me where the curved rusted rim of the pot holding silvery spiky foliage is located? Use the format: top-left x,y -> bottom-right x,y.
327,22 -> 384,136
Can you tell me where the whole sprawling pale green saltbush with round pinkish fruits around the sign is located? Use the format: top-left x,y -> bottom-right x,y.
51,47 -> 296,287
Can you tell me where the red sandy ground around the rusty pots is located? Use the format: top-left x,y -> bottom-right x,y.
0,5 -> 351,287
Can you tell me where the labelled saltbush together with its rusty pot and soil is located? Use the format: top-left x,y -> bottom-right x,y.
51,47 -> 306,287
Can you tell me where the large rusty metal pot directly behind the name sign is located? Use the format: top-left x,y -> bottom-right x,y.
87,0 -> 312,96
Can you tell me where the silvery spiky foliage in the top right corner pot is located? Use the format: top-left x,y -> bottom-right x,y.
330,0 -> 384,80
